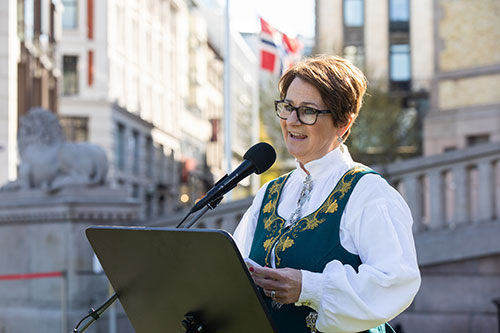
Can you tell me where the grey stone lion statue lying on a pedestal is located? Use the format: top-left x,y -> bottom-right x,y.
1,107 -> 108,192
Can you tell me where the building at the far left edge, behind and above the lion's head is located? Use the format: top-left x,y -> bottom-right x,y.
0,0 -> 62,185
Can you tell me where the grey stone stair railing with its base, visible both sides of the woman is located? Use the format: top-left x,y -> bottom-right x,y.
152,142 -> 500,265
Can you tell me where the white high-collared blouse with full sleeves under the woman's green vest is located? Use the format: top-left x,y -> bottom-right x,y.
233,145 -> 420,332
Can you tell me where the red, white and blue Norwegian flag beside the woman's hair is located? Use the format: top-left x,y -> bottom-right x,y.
260,18 -> 303,75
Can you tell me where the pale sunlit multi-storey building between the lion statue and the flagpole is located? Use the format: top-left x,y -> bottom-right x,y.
59,0 -> 198,219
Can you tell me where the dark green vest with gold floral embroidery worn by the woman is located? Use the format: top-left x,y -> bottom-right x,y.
249,165 -> 392,333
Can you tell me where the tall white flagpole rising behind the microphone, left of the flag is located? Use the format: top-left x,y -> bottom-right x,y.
224,0 -> 233,201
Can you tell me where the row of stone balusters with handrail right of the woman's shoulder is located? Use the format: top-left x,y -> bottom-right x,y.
376,142 -> 500,233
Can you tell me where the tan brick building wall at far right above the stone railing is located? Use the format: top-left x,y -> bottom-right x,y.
424,0 -> 500,155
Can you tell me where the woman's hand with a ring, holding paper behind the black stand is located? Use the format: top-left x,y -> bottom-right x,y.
250,267 -> 302,304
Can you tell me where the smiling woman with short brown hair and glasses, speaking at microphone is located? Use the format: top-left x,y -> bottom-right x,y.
234,56 -> 420,333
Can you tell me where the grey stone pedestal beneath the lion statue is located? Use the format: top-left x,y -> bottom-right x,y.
0,187 -> 140,332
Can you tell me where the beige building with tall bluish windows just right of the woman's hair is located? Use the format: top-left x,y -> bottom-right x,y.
314,0 -> 434,163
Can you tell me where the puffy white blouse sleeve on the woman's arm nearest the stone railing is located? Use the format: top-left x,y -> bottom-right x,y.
296,175 -> 420,332
